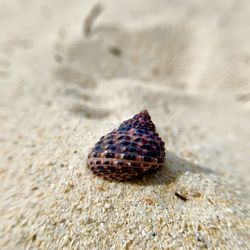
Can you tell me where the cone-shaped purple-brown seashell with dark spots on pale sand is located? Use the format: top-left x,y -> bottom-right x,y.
87,110 -> 165,181
